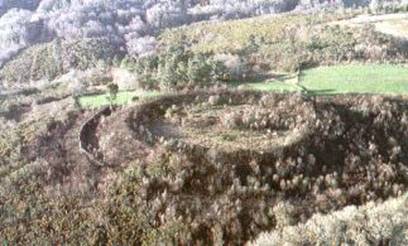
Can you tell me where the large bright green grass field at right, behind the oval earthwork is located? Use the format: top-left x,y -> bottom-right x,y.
244,64 -> 408,95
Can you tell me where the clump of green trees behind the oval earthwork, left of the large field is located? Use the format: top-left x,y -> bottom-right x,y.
122,42 -> 226,90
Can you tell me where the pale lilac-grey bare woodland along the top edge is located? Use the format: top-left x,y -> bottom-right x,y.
0,0 -> 403,66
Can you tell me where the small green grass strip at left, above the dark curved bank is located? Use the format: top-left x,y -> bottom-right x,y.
79,90 -> 159,108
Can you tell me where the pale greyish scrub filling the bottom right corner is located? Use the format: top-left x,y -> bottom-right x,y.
251,195 -> 408,245
